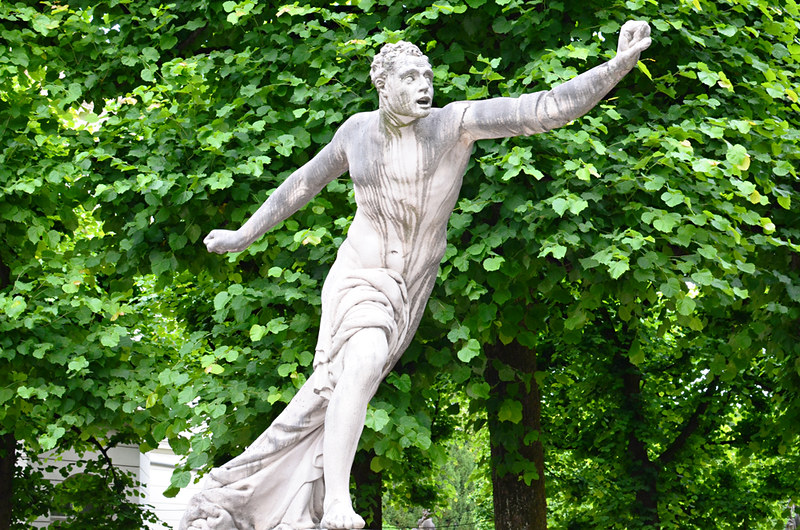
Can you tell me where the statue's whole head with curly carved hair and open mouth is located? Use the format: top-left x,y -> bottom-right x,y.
370,41 -> 433,122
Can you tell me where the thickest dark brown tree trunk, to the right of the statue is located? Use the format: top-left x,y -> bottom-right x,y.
486,342 -> 547,530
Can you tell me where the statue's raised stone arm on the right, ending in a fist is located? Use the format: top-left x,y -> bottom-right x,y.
462,21 -> 651,140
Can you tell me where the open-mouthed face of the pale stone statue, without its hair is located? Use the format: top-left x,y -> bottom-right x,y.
378,55 -> 433,122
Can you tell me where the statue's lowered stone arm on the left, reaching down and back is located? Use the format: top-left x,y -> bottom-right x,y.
203,129 -> 347,254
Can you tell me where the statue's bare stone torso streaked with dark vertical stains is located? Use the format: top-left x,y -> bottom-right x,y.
342,107 -> 472,283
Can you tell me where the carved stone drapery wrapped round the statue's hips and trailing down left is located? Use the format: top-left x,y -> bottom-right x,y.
179,266 -> 414,530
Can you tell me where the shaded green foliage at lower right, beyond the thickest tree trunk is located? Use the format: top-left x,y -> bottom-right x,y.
542,304 -> 798,528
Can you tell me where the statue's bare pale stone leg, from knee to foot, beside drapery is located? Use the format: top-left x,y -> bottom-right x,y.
320,328 -> 389,529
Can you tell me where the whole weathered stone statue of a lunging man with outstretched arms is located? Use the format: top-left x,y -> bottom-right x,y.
181,21 -> 650,530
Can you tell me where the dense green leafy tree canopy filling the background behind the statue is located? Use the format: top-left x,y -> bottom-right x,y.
0,0 -> 800,528
